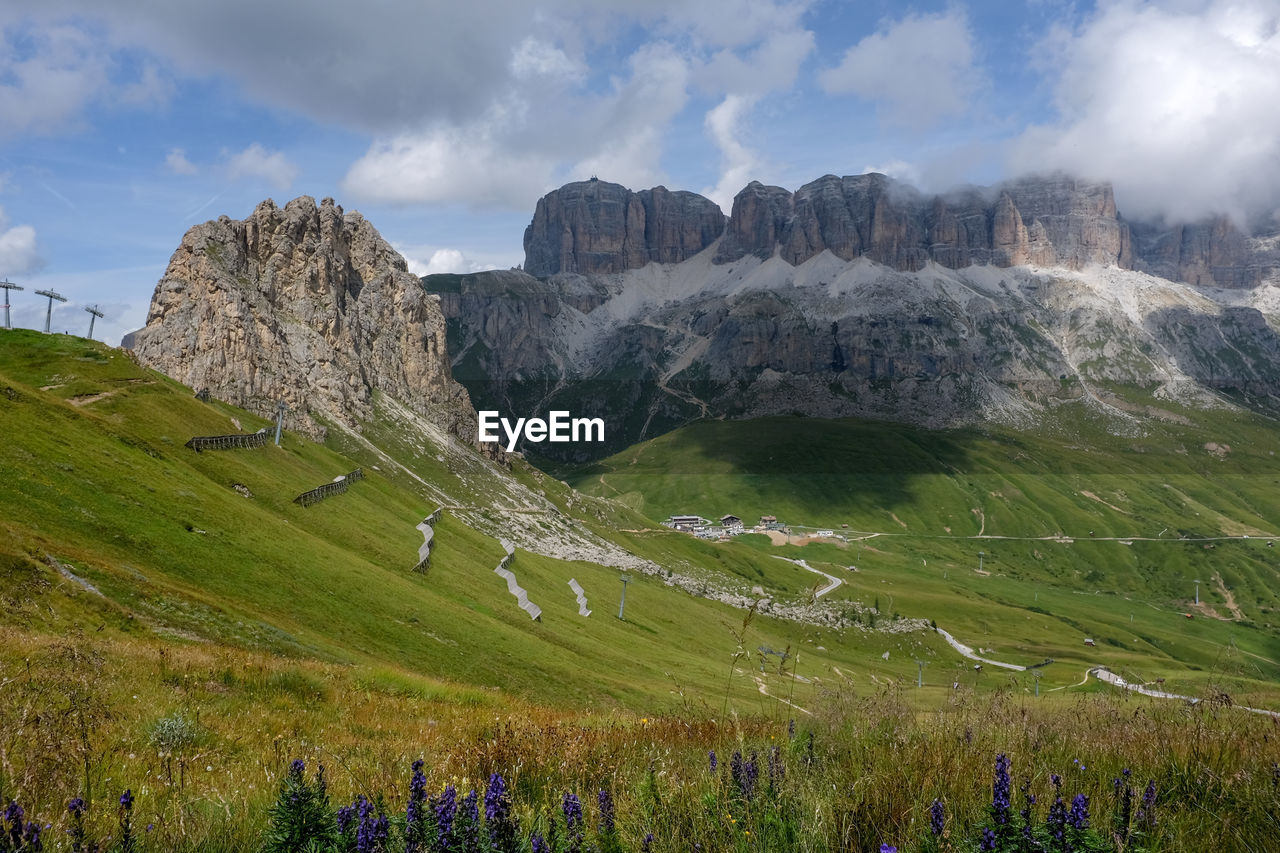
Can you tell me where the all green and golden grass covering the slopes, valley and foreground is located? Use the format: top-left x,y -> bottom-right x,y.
0,332 -> 1280,850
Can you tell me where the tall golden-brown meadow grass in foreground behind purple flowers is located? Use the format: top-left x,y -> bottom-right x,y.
0,622 -> 1280,852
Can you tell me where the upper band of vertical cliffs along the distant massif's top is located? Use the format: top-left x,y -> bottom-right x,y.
524,173 -> 1280,287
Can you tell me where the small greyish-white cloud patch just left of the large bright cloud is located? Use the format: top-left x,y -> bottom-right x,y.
818,8 -> 983,129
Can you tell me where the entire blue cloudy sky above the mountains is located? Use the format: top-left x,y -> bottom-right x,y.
0,0 -> 1280,343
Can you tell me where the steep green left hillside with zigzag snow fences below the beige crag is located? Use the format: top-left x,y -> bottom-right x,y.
0,332 -> 946,710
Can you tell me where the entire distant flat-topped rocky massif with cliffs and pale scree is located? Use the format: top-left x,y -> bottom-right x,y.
437,174 -> 1280,459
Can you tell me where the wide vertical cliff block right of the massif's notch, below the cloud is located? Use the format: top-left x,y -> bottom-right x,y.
716,173 -> 1133,270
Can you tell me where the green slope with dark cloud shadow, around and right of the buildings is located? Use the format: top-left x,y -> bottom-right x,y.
568,401 -> 1280,704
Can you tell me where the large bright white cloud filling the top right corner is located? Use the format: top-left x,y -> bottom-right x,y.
1011,0 -> 1280,220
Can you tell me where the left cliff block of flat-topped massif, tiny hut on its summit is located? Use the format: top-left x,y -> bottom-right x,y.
525,178 -> 724,275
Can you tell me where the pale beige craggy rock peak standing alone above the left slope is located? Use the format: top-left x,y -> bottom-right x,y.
132,196 -> 476,443
